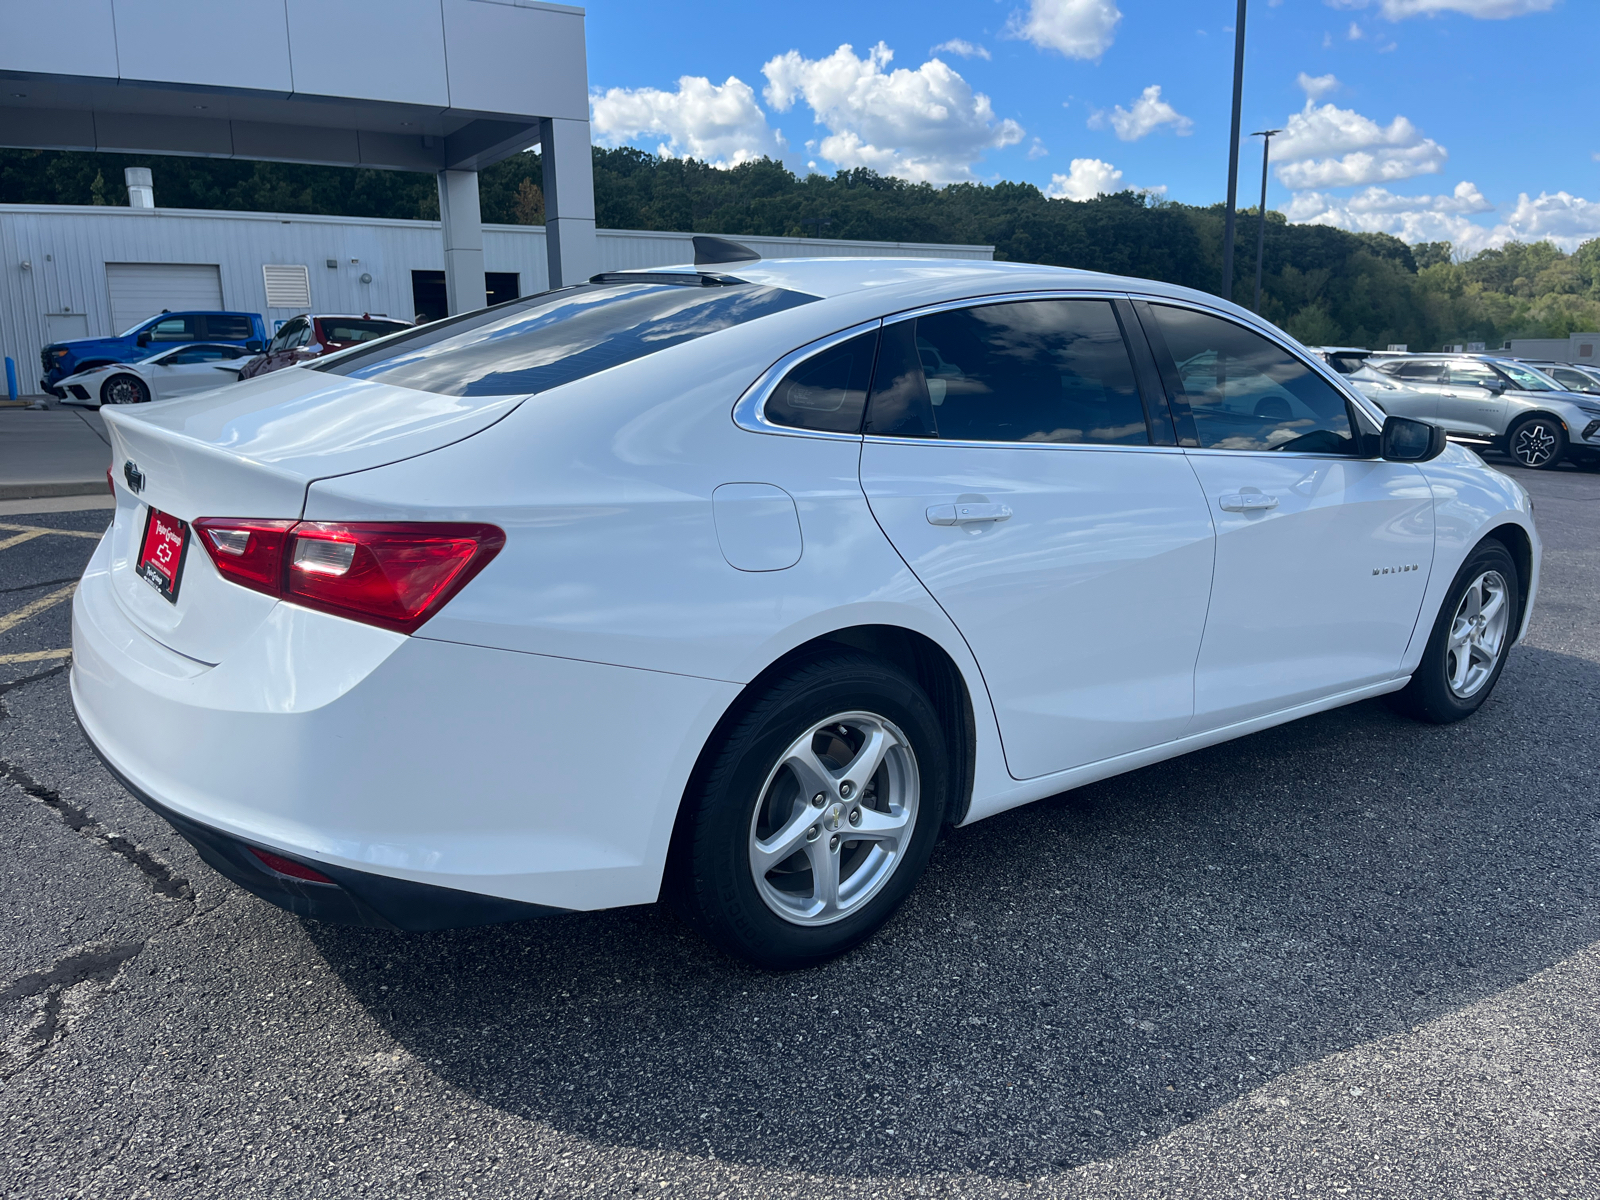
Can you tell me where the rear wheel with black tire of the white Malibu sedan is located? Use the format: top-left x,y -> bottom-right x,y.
669,651 -> 950,970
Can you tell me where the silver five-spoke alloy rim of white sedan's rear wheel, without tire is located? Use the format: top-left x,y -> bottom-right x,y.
749,712 -> 920,925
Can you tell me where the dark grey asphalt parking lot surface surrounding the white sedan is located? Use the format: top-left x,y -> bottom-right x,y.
0,454 -> 1600,1200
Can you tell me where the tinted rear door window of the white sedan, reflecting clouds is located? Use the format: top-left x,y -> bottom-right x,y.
869,299 -> 1150,446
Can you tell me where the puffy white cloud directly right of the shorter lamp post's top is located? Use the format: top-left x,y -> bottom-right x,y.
1272,89 -> 1450,189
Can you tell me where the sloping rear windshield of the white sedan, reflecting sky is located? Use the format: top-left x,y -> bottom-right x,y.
312,282 -> 818,395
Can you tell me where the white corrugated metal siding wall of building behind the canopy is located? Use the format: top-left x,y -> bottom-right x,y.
0,205 -> 994,392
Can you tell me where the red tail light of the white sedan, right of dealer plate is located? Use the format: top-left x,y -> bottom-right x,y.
194,517 -> 506,634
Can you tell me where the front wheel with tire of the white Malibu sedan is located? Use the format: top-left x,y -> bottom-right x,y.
1392,541 -> 1522,725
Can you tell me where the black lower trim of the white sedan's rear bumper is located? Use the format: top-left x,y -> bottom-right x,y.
74,712 -> 570,933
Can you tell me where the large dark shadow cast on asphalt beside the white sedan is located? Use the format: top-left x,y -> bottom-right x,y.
306,646 -> 1600,1178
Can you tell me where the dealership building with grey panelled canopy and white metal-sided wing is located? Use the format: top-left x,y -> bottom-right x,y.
0,0 -> 990,390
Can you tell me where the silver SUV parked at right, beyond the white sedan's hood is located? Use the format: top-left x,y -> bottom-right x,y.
1349,354 -> 1600,469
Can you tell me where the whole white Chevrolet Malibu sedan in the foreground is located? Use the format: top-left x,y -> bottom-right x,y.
72,238 -> 1539,966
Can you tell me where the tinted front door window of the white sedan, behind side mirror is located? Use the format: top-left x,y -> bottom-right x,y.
1150,304 -> 1357,454
